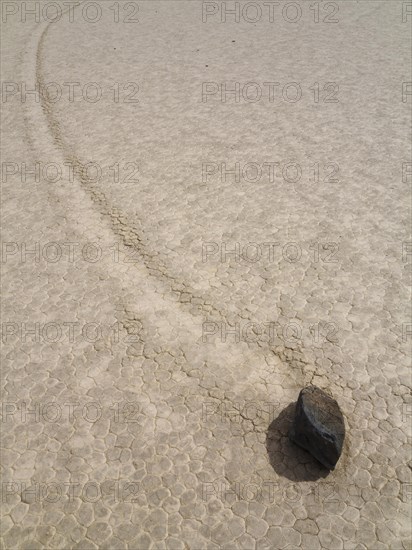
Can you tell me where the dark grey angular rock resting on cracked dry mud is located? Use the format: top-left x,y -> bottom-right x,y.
289,386 -> 345,470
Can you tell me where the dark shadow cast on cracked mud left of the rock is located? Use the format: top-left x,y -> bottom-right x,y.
266,403 -> 330,481
